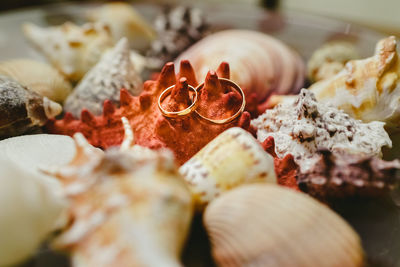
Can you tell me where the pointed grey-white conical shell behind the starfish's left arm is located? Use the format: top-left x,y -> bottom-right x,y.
64,38 -> 143,117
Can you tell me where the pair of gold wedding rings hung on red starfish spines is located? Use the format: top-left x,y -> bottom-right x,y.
158,78 -> 246,124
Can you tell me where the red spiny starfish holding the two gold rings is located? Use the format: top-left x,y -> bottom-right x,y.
46,61 -> 250,164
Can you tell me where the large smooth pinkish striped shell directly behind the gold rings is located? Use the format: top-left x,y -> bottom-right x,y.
175,30 -> 304,102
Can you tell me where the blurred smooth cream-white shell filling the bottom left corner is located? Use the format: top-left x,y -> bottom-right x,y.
0,157 -> 66,266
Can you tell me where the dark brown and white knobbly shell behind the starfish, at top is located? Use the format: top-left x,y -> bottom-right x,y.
147,5 -> 209,69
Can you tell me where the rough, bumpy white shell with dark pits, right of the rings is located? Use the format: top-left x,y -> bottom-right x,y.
251,89 -> 392,169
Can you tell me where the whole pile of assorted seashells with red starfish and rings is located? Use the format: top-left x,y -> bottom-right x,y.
0,2 -> 400,267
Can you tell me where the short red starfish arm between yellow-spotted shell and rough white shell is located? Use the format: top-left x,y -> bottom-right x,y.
262,136 -> 300,191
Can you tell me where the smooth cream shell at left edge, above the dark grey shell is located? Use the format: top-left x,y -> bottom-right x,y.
0,59 -> 72,103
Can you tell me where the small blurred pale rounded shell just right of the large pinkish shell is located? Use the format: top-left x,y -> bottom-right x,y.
307,41 -> 359,82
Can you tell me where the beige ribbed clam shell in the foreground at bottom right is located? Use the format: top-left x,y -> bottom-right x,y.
204,184 -> 364,267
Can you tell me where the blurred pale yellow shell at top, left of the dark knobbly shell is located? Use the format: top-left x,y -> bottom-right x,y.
87,2 -> 155,50
